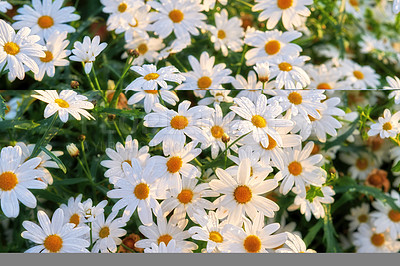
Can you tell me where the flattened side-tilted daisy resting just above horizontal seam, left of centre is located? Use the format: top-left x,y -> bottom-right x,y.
126,65 -> 185,91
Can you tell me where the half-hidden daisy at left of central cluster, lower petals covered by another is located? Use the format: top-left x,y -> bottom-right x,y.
100,135 -> 150,184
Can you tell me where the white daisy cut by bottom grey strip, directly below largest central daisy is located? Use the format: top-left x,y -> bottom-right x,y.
221,213 -> 287,253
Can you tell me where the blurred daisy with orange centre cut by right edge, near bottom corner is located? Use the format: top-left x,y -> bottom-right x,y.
370,190 -> 400,239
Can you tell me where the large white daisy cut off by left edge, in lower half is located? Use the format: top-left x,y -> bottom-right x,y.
0,146 -> 47,217
